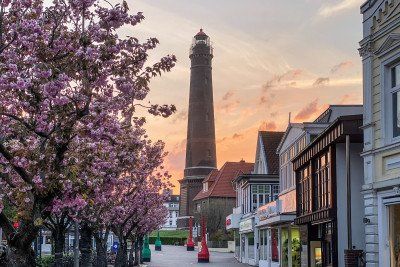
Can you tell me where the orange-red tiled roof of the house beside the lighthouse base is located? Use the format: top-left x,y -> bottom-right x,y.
193,160 -> 254,200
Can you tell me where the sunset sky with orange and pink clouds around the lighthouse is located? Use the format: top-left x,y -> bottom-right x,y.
122,0 -> 363,193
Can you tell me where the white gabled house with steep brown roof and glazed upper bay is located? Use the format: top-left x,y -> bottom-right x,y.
226,131 -> 283,266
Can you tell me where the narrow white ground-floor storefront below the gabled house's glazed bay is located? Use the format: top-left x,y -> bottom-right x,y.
239,216 -> 258,266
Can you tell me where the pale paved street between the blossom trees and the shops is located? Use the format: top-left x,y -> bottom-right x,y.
148,245 -> 248,267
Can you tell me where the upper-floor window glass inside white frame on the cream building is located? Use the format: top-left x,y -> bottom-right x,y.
390,64 -> 400,137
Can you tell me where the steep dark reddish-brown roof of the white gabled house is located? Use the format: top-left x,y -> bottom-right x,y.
258,131 -> 285,174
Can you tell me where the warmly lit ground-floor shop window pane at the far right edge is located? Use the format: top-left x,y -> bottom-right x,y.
389,204 -> 400,267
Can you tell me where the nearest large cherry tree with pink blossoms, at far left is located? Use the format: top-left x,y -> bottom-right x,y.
0,0 -> 176,266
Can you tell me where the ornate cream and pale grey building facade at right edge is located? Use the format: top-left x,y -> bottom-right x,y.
359,0 -> 400,267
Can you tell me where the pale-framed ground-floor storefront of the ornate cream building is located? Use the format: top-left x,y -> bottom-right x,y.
378,187 -> 400,267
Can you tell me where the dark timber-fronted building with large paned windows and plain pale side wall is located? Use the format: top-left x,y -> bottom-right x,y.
292,115 -> 365,267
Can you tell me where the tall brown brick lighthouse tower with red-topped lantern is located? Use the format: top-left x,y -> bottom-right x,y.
178,29 -> 217,227
